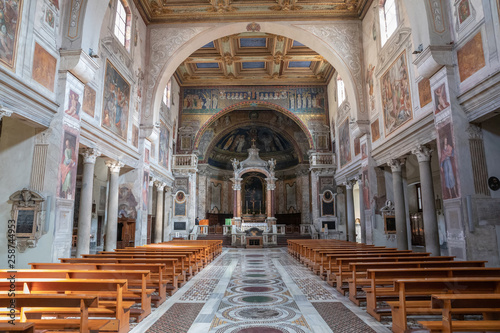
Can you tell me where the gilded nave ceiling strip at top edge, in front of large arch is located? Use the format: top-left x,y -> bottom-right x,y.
134,0 -> 372,23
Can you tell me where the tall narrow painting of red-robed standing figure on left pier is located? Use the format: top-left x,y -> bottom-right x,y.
58,128 -> 78,200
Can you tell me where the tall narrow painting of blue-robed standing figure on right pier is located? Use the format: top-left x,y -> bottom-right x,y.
437,121 -> 460,200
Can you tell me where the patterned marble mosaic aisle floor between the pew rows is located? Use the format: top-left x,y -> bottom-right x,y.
130,248 -> 389,333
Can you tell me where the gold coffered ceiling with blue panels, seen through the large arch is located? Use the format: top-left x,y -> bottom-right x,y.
175,32 -> 334,86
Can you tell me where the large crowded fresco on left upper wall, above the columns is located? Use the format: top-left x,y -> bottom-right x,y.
102,60 -> 130,140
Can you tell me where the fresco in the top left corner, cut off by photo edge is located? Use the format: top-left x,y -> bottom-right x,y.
0,0 -> 23,70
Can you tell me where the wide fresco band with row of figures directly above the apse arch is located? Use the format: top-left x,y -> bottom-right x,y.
182,86 -> 327,115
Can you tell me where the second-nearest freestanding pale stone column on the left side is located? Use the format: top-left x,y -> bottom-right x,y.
104,161 -> 123,251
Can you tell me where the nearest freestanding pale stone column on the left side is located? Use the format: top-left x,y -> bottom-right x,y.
76,149 -> 101,258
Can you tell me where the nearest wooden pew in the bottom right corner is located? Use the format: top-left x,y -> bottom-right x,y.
418,294 -> 500,333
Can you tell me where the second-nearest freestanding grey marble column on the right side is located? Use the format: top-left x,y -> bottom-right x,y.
388,159 -> 408,250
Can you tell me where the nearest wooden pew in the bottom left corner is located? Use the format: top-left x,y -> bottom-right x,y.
0,293 -> 99,333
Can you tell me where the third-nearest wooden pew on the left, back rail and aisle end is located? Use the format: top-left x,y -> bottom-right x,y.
29,263 -> 170,307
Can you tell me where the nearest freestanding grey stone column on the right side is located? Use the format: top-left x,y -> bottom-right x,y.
412,145 -> 441,256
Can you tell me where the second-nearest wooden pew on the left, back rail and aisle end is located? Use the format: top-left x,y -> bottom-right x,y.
0,269 -> 155,322
